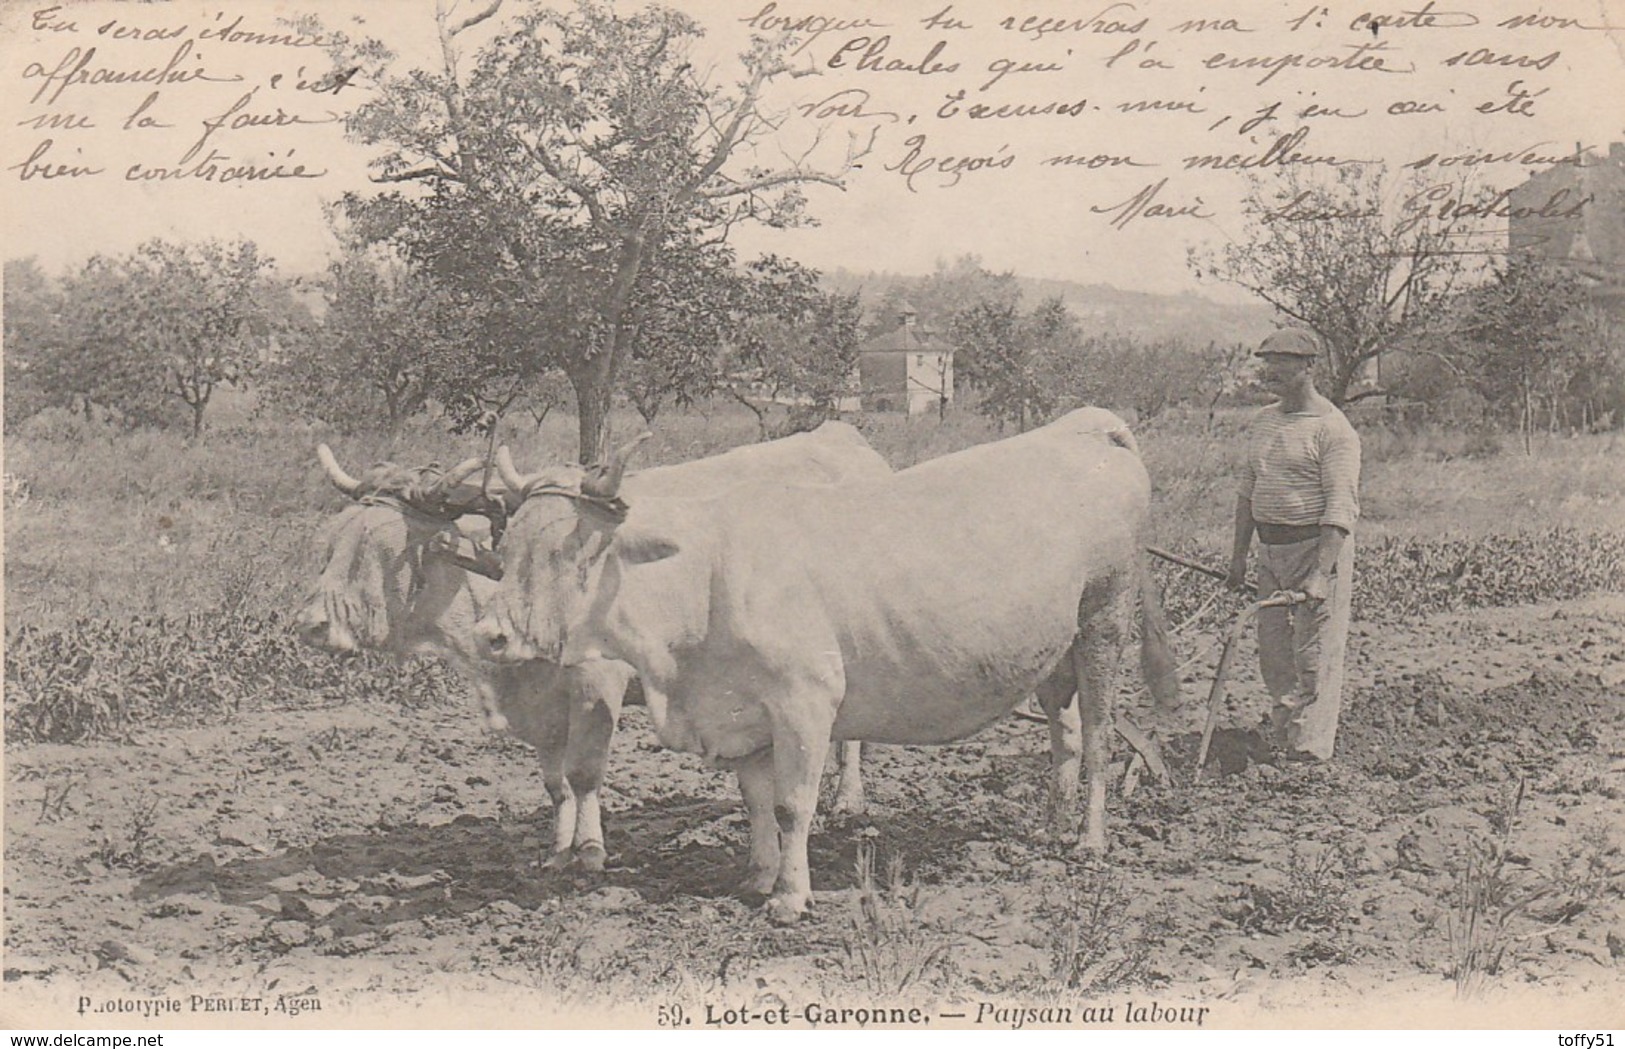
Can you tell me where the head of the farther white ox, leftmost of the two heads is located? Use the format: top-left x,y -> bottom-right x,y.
294,445 -> 501,653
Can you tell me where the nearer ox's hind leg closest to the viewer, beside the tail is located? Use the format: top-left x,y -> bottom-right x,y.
1073,586 -> 1134,853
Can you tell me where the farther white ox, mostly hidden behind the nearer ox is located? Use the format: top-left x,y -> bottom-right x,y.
296,422 -> 891,870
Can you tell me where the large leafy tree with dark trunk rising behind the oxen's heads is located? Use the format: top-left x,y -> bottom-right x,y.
323,0 -> 866,458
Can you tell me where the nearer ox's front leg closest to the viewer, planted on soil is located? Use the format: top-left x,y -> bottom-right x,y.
767,692 -> 835,924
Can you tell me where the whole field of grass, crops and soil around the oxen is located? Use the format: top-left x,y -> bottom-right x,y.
0,409 -> 1625,1028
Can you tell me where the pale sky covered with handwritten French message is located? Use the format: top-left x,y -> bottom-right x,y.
0,0 -> 1625,297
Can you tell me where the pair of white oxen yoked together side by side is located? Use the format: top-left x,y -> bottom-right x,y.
297,408 -> 1177,921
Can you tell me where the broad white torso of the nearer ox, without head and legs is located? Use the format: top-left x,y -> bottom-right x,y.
565,409 -> 1151,757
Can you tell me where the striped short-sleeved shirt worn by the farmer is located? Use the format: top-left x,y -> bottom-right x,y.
1240,404 -> 1360,531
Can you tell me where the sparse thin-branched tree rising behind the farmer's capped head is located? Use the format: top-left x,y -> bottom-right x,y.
1190,164 -> 1467,404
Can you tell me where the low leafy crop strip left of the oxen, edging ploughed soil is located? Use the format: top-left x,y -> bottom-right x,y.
5,612 -> 457,742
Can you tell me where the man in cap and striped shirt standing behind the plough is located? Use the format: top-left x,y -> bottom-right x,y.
1227,328 -> 1360,760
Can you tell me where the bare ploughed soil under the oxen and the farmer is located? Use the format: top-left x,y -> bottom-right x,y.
0,596 -> 1625,1030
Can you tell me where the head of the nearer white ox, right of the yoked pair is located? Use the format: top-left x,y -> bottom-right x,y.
475,434 -> 650,663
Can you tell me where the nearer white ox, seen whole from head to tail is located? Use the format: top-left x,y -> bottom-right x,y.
476,409 -> 1177,921
